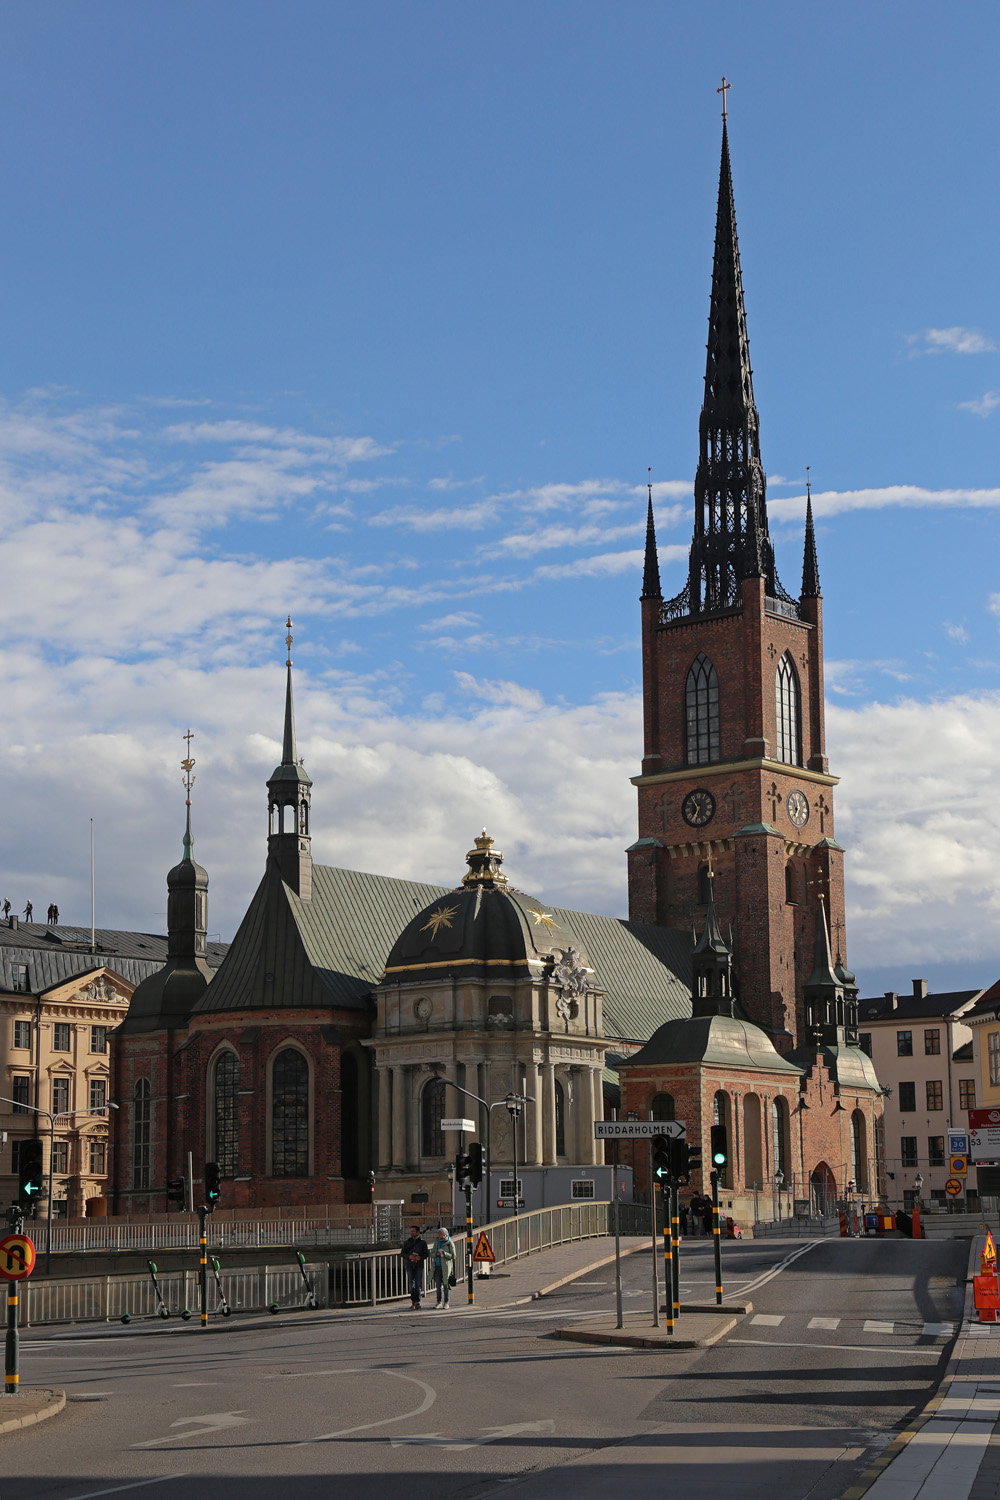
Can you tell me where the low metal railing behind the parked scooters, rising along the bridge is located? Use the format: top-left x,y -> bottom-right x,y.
21,1203 -> 609,1328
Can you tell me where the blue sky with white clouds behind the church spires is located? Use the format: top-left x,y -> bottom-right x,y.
0,0 -> 1000,992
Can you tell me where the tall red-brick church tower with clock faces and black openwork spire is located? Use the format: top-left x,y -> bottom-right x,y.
628,114 -> 844,1052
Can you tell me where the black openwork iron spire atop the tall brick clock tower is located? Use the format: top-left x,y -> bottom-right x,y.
664,123 -> 792,618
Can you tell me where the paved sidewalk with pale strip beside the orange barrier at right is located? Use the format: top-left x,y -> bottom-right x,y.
844,1235 -> 1000,1500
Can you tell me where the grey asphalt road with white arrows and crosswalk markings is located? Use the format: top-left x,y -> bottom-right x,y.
0,1241 -> 969,1500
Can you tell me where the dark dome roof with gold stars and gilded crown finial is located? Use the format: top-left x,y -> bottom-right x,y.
385,830 -> 586,981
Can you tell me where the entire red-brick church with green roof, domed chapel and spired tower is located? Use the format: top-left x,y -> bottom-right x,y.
111,120 -> 882,1218
